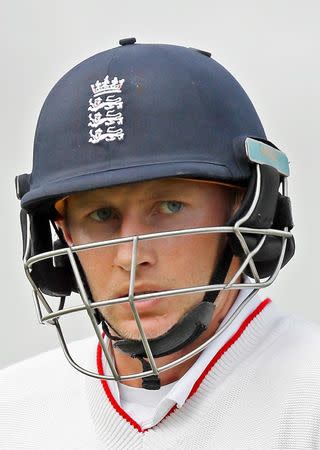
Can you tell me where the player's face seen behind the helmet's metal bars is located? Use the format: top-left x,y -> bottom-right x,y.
59,178 -> 234,339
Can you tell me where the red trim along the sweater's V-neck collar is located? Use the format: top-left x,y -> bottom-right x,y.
97,298 -> 271,433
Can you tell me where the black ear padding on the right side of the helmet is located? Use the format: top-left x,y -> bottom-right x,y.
228,165 -> 295,278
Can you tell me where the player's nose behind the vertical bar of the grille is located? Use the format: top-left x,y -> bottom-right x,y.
113,218 -> 156,272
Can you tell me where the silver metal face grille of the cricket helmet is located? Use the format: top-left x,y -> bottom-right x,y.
24,165 -> 292,381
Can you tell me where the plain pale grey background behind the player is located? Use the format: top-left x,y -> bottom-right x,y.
0,0 -> 320,367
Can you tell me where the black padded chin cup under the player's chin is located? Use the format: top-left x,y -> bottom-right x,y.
113,302 -> 215,358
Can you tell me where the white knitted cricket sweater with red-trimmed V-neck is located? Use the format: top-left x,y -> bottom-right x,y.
0,302 -> 320,450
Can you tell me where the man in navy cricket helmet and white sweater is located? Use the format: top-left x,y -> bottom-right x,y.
0,38 -> 320,449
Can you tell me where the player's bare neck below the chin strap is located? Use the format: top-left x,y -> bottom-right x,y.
114,290 -> 238,387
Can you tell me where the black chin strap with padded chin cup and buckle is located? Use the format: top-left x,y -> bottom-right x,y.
102,244 -> 233,389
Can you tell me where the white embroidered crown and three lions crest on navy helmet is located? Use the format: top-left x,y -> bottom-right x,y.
88,75 -> 125,144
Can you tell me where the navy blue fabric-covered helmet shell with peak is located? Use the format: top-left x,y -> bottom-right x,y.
21,43 -> 265,210
